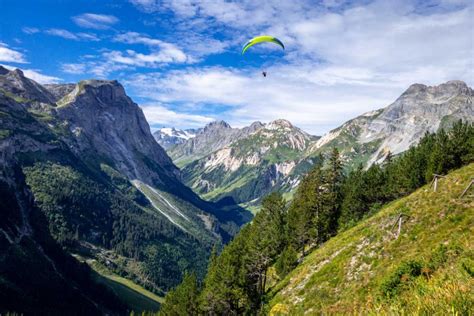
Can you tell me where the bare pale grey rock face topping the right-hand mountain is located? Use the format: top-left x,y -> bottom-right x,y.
359,81 -> 474,163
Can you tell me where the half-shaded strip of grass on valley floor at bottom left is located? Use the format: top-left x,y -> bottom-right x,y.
90,261 -> 163,312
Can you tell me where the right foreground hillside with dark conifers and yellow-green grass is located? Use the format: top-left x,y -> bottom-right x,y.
156,122 -> 474,315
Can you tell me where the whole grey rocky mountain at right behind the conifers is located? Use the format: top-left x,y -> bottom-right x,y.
308,81 -> 474,165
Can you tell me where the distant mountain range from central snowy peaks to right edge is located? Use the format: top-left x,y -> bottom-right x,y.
162,81 -> 474,207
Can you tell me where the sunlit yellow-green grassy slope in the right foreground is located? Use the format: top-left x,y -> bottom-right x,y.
268,164 -> 474,315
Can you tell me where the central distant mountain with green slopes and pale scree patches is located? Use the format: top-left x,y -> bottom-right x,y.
182,120 -> 318,209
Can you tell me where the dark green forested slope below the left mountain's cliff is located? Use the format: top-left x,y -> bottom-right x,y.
24,162 -> 210,293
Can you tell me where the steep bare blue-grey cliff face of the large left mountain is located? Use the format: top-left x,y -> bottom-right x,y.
57,80 -> 179,185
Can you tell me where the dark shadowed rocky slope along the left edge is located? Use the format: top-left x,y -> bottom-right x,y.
0,68 -> 127,315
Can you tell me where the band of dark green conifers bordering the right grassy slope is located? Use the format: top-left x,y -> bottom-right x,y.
160,121 -> 474,315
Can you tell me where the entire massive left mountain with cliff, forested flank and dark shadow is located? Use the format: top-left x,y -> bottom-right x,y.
0,68 -> 250,314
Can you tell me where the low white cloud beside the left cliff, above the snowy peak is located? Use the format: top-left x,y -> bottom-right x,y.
141,104 -> 215,129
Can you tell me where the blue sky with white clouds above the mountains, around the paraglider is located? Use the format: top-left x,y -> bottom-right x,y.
0,0 -> 474,135
